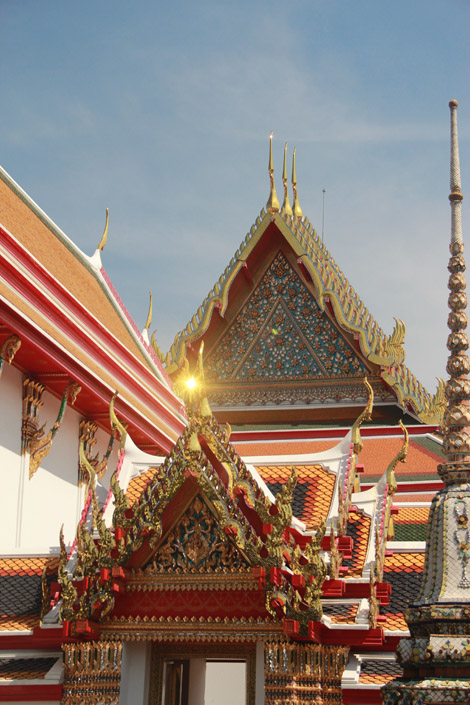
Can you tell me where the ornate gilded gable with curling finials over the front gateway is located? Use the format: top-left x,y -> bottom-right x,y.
59,402 -> 326,630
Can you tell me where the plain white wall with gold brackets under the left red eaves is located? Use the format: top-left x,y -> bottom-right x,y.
0,365 -> 123,554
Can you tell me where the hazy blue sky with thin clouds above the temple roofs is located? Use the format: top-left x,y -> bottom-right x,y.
0,0 -> 470,390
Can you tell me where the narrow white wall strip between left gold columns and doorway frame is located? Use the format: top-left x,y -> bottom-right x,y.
119,642 -> 151,705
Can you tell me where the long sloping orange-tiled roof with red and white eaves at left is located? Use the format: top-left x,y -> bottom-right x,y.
0,169 -> 185,451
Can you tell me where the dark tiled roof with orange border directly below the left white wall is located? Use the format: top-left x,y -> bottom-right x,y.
0,556 -> 59,631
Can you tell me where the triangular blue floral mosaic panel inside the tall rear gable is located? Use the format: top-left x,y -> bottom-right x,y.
205,252 -> 367,382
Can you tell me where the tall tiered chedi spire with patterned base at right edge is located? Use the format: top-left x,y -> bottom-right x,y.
382,100 -> 470,705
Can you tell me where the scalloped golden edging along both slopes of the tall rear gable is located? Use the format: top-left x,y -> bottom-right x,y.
161,197 -> 444,423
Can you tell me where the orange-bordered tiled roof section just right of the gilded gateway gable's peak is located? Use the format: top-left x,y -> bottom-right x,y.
256,465 -> 336,529
